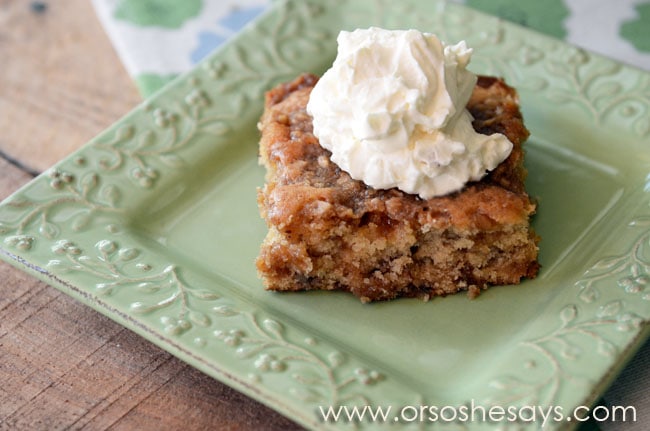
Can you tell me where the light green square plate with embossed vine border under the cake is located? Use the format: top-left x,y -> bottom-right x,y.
0,0 -> 650,429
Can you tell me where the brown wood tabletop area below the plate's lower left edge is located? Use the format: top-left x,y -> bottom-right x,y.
0,255 -> 298,430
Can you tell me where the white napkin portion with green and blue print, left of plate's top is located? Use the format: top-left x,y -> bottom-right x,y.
93,0 -> 271,96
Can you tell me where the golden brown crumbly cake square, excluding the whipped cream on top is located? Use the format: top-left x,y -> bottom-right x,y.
257,74 -> 539,302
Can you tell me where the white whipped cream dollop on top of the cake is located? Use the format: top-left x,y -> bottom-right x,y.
307,27 -> 512,199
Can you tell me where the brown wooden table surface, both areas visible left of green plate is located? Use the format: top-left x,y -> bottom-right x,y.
0,0 -> 299,430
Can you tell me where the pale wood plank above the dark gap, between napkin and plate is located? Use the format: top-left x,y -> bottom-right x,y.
0,0 -> 140,175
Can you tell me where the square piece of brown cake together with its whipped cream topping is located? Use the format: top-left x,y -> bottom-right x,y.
257,27 -> 539,302
